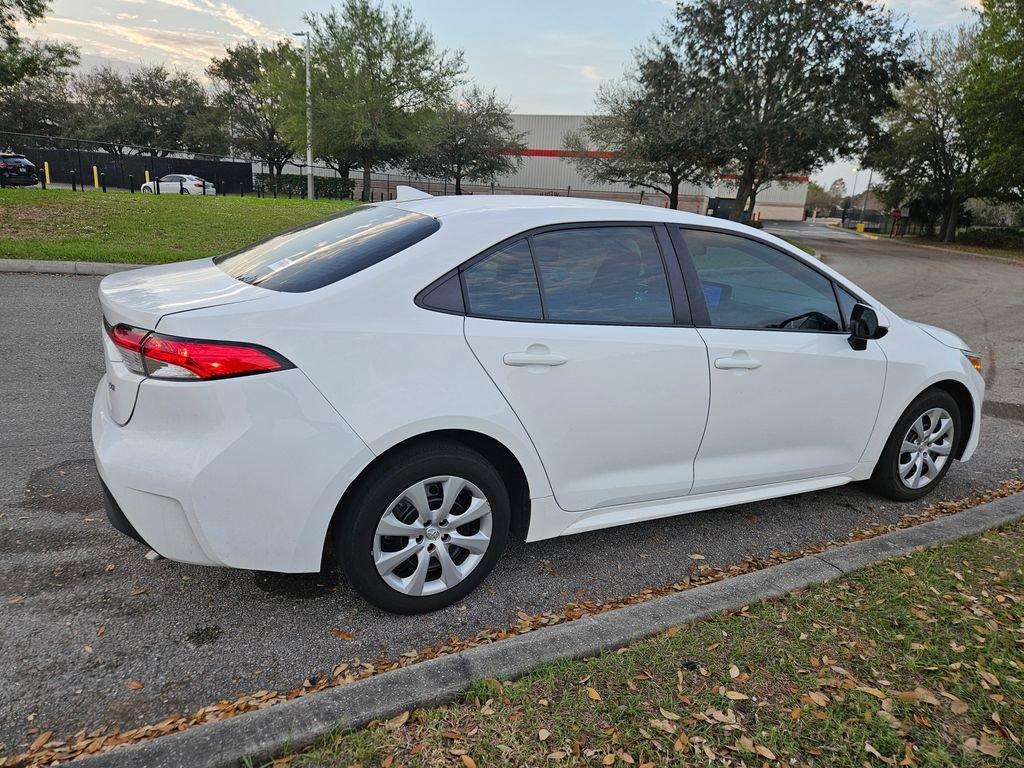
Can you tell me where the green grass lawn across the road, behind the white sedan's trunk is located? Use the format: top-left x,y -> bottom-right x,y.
0,189 -> 353,264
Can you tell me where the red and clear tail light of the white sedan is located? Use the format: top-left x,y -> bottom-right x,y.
108,325 -> 295,381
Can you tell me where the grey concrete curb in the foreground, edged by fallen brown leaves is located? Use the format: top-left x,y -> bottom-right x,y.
75,494 -> 1024,768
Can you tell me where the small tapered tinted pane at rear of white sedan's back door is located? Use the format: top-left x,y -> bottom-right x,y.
463,240 -> 542,319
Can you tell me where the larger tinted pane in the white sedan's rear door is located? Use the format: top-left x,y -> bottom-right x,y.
534,226 -> 673,324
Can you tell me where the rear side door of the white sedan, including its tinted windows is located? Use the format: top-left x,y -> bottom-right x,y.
461,224 -> 709,511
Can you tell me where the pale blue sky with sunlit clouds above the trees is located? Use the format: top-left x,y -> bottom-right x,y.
27,0 -> 978,190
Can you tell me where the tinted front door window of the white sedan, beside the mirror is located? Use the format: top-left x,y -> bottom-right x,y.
683,229 -> 843,331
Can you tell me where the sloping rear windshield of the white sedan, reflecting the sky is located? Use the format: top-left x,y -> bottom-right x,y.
214,206 -> 440,293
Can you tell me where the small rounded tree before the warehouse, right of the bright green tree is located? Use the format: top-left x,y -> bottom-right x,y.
409,86 -> 526,195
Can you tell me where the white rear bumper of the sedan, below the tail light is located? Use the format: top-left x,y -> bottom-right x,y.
92,370 -> 372,572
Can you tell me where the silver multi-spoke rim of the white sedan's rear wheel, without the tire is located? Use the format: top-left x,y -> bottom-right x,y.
373,475 -> 493,597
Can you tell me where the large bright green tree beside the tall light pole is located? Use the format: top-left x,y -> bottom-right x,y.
272,0 -> 464,200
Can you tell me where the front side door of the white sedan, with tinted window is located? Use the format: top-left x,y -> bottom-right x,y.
672,227 -> 886,494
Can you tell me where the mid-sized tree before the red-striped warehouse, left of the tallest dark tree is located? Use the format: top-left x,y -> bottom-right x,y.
565,42 -> 729,208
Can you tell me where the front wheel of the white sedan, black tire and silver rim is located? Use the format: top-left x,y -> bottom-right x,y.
871,389 -> 962,502
